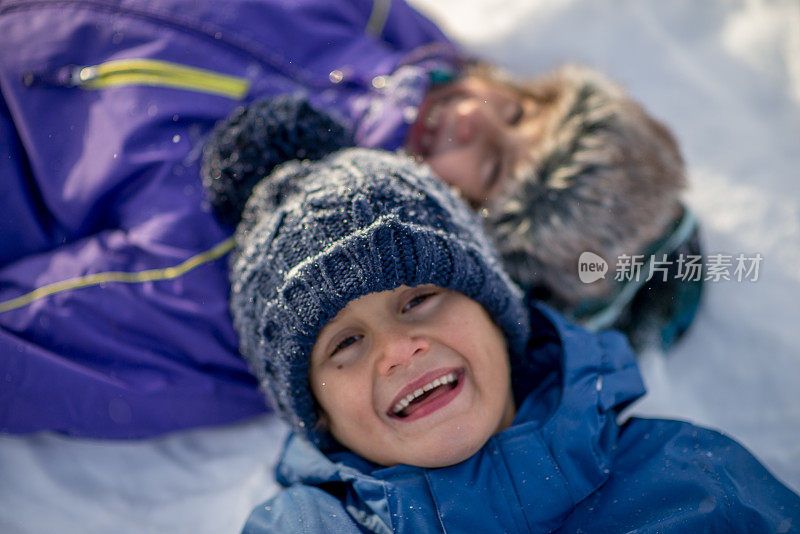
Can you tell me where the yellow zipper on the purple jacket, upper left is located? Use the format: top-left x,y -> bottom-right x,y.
25,59 -> 250,100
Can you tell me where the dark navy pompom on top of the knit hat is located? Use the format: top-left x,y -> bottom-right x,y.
201,94 -> 353,225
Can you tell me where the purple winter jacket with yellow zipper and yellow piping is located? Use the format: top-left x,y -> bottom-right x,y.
0,0 -> 454,438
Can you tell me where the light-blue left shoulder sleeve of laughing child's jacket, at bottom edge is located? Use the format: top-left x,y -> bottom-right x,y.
242,486 -> 362,534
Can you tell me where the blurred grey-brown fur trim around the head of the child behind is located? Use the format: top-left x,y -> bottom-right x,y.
484,66 -> 685,311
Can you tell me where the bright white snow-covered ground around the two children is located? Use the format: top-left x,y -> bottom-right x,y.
0,0 -> 800,534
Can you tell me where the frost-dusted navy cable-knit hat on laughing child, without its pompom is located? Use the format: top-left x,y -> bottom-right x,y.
230,149 -> 529,449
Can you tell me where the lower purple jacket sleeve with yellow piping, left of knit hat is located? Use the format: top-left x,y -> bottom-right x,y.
0,191 -> 265,438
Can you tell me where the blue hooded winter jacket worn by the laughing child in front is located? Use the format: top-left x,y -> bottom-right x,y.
244,309 -> 800,534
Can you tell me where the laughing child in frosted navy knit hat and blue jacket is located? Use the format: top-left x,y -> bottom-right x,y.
216,149 -> 800,533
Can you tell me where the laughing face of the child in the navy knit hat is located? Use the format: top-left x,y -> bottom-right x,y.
309,285 -> 514,467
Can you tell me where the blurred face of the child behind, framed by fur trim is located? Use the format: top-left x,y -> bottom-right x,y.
406,77 -> 546,205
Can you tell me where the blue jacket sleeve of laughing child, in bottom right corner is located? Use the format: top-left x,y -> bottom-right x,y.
561,417 -> 800,534
